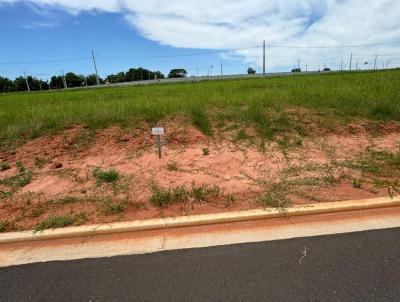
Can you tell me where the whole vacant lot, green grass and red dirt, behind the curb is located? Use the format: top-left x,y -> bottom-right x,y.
0,71 -> 400,231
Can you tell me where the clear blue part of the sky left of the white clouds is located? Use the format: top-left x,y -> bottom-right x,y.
0,3 -> 255,79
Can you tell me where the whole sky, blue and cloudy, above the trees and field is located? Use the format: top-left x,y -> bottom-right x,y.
0,0 -> 400,79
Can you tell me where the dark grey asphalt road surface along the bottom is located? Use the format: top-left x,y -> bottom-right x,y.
0,228 -> 400,301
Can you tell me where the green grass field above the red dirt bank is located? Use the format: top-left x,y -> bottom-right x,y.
0,70 -> 400,146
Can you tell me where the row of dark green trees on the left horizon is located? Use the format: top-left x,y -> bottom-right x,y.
0,67 -> 187,93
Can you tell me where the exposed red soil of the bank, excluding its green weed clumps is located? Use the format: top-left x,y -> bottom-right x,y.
0,121 -> 400,228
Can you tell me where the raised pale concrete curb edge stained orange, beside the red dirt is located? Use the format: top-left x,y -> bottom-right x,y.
0,196 -> 400,244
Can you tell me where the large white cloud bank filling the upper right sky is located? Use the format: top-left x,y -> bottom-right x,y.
0,0 -> 400,68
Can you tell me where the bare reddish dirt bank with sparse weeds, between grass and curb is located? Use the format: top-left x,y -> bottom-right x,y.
0,121 -> 400,231
